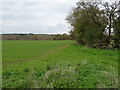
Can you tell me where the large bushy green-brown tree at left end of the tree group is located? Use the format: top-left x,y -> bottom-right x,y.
66,2 -> 107,47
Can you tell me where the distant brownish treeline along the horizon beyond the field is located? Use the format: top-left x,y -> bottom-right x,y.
2,33 -> 73,40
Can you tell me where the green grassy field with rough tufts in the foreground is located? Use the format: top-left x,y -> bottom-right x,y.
2,41 -> 118,88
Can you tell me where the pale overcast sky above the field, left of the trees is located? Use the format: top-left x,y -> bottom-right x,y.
0,0 -> 78,34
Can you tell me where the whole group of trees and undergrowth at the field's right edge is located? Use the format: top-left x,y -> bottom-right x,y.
66,1 -> 120,48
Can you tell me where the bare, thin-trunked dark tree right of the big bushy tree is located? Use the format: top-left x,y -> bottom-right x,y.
99,1 -> 120,43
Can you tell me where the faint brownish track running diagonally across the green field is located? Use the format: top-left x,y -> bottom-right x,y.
2,44 -> 69,66
